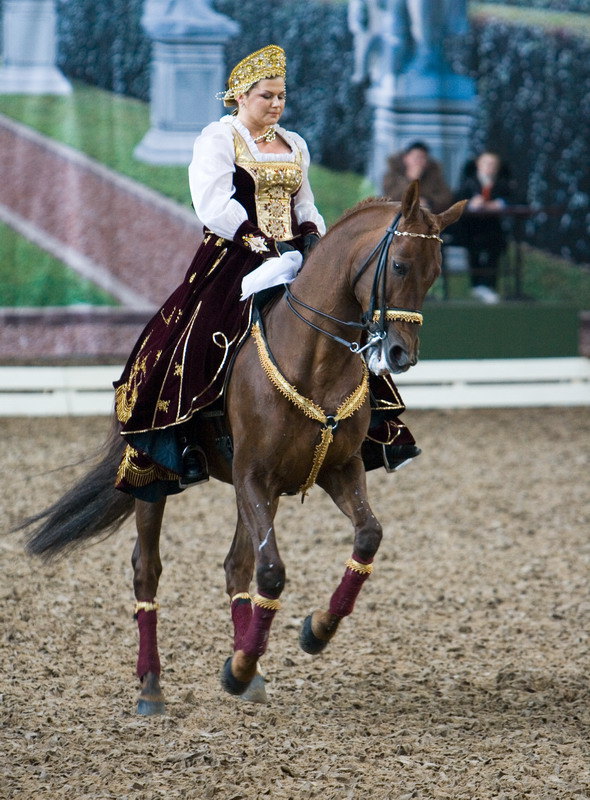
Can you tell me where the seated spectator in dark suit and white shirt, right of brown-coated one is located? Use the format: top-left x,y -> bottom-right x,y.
448,150 -> 514,303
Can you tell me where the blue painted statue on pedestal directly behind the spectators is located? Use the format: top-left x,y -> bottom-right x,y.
349,0 -> 476,192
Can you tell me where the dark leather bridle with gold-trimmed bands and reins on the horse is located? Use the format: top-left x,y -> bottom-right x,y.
285,211 -> 442,353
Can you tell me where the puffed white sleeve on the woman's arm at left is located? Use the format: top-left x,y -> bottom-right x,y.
188,122 -> 248,239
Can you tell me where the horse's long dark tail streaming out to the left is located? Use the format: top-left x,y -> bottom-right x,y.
15,426 -> 134,559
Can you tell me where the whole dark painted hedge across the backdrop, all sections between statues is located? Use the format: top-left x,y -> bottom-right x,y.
0,0 -> 590,263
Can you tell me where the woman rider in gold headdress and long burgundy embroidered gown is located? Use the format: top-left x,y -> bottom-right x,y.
115,45 -> 416,501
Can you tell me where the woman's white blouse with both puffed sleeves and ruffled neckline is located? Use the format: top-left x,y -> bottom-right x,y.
188,114 -> 326,239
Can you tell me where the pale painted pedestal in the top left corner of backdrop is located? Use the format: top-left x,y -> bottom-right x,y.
0,0 -> 72,94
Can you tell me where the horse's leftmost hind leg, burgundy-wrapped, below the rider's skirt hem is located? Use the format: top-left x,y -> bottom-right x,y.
131,498 -> 166,716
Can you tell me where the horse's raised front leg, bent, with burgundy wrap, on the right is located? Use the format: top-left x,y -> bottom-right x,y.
299,458 -> 382,655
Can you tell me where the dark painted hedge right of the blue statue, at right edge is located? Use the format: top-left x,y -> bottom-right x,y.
454,17 -> 590,263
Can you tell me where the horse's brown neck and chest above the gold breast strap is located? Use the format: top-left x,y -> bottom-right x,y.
265,239 -> 362,405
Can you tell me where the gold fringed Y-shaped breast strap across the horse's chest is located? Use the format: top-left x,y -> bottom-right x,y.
252,322 -> 369,497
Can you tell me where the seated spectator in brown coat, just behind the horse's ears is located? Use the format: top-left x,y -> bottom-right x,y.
383,142 -> 453,214
